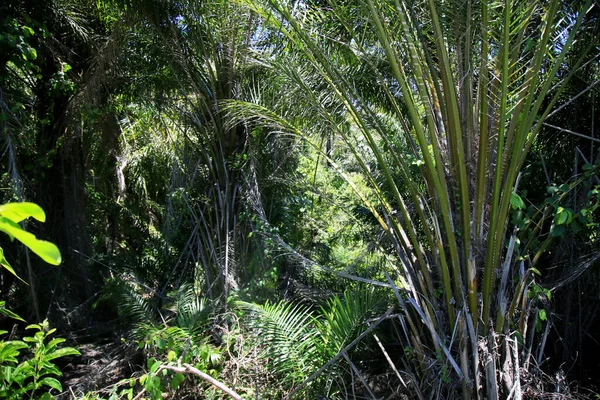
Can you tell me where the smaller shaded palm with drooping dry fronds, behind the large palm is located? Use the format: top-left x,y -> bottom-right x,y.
109,0 -> 266,304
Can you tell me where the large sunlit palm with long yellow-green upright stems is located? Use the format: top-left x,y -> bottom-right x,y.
228,0 -> 595,399
